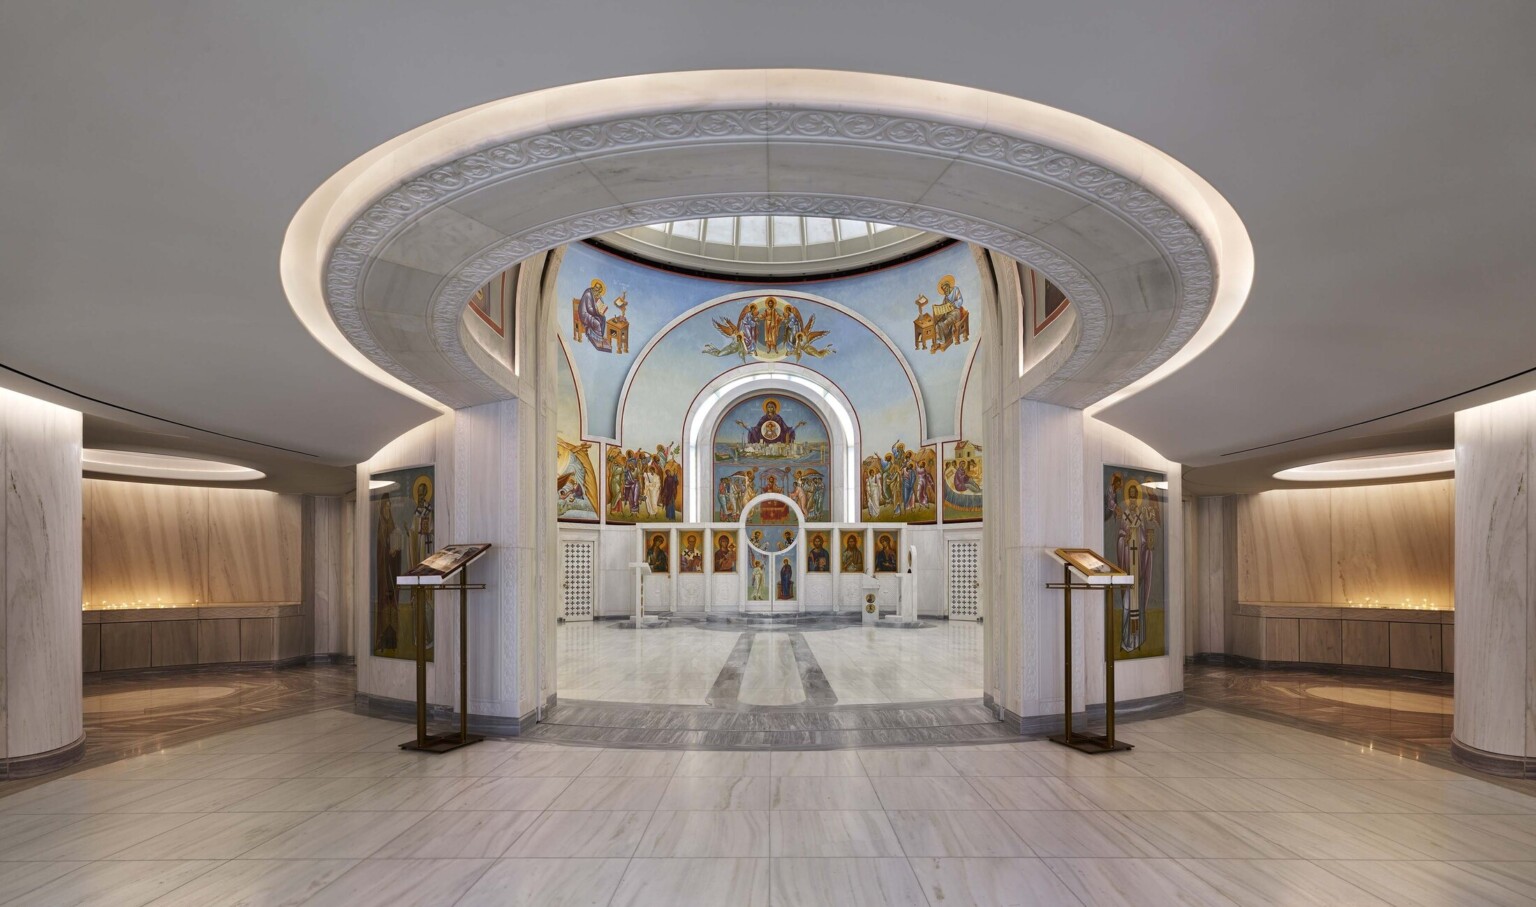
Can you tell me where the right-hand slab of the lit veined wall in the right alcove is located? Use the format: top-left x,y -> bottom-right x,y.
1329,480 -> 1456,603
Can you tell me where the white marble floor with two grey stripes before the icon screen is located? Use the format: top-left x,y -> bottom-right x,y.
558,620 -> 982,707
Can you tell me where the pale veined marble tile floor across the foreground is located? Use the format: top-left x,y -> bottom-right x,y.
0,709 -> 1536,907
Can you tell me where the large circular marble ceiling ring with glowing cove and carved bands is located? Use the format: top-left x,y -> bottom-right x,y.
283,71 -> 1252,406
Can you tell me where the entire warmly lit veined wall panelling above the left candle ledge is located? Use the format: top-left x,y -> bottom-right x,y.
81,478 -> 303,604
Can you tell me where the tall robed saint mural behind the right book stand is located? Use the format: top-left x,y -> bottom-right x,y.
1104,466 -> 1167,659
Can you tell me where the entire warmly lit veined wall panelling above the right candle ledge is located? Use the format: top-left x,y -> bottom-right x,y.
1238,480 -> 1456,606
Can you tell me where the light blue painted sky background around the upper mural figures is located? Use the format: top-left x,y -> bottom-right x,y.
554,243 -> 982,449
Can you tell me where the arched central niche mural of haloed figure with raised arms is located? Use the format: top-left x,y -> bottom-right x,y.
713,394 -> 833,523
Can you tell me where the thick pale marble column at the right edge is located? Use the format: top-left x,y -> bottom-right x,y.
1452,394 -> 1536,778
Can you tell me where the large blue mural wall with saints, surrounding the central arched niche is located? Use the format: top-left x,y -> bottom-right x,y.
554,236 -> 985,525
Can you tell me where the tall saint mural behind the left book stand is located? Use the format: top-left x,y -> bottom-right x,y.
369,466 -> 438,661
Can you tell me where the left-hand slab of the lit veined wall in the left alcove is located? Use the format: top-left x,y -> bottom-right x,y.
81,478 -> 210,603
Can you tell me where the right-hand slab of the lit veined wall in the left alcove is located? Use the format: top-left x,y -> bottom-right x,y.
207,489 -> 303,601
